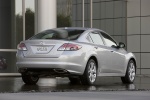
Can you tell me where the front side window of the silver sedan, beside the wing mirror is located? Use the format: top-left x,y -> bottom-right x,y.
101,32 -> 117,47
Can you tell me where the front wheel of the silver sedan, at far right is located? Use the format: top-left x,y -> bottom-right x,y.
121,60 -> 136,84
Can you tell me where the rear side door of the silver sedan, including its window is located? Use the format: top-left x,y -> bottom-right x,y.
89,31 -> 111,73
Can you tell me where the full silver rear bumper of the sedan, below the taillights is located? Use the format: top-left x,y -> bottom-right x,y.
16,56 -> 86,75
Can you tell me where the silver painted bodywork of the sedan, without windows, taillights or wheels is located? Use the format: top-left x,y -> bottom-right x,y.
16,28 -> 136,76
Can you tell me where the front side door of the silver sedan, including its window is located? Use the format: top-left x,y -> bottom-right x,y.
101,32 -> 125,73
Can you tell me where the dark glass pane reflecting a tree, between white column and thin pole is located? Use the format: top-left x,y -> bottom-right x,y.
57,0 -> 83,27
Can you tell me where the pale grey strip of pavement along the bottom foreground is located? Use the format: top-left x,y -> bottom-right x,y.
0,91 -> 150,100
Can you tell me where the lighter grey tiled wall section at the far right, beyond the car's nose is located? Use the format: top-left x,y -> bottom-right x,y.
127,0 -> 150,74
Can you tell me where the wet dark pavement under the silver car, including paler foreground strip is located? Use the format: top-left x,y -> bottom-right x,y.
0,76 -> 150,100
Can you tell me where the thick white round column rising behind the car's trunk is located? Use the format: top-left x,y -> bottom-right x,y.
35,0 -> 57,33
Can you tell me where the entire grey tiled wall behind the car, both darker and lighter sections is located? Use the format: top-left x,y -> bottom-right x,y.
72,0 -> 150,74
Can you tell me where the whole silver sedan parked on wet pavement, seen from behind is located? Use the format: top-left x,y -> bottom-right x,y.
16,27 -> 136,85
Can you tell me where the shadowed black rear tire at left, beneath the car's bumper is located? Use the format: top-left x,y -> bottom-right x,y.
22,74 -> 39,85
